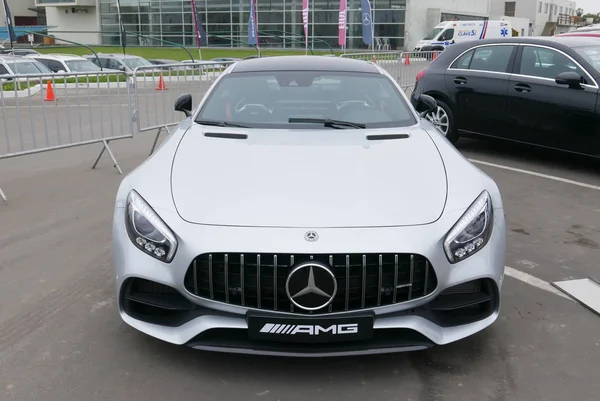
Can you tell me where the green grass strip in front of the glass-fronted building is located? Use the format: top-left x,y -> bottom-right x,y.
36,46 -> 341,61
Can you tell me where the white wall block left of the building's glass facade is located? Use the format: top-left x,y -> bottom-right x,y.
46,6 -> 100,45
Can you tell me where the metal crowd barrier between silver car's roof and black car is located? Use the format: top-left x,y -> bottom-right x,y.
341,51 -> 439,95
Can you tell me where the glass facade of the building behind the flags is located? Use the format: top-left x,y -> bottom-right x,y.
100,0 -> 406,50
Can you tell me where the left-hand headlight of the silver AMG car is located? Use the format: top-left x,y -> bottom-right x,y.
125,190 -> 177,263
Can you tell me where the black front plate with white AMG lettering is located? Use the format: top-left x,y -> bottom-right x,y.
248,315 -> 373,343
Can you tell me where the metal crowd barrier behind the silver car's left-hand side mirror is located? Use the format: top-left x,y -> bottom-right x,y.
130,62 -> 233,154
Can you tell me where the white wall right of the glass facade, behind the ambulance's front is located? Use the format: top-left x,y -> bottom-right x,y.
404,0 -> 490,50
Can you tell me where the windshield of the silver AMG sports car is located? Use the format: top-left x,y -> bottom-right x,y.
196,71 -> 417,129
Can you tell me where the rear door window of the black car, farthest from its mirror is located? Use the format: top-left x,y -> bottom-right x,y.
451,45 -> 515,72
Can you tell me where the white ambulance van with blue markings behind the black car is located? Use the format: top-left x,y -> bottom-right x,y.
415,20 -> 512,51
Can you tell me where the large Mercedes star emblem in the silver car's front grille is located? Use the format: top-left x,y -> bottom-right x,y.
285,262 -> 337,311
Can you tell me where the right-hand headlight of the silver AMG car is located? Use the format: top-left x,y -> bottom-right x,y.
444,191 -> 494,263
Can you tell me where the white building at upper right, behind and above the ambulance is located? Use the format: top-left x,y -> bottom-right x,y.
491,0 -> 577,36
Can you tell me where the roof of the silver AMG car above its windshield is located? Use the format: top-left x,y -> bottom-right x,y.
231,56 -> 381,74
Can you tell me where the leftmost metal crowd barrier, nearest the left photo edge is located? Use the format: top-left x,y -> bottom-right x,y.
0,72 -> 134,202
